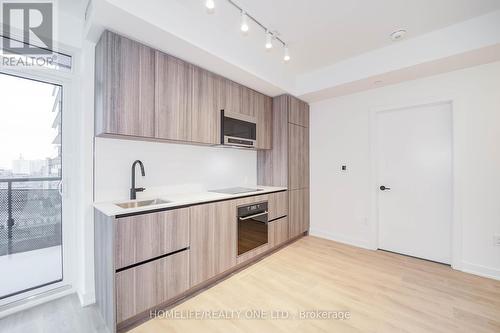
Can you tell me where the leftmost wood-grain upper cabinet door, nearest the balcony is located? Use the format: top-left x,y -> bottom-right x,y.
95,31 -> 155,137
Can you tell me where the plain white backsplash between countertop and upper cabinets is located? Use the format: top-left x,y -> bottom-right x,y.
94,138 -> 257,202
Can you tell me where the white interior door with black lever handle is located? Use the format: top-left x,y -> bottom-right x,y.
376,103 -> 452,263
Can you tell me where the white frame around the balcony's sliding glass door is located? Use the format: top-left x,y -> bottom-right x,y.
0,65 -> 79,308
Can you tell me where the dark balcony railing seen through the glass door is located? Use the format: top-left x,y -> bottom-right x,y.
0,177 -> 62,256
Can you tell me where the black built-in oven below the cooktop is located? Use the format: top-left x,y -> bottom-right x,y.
237,202 -> 268,255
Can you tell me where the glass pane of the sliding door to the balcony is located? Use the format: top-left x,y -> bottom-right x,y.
0,73 -> 63,303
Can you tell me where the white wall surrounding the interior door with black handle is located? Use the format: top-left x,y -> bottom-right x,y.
310,62 -> 500,279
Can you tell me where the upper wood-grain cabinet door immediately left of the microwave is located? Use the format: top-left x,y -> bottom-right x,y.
191,67 -> 222,144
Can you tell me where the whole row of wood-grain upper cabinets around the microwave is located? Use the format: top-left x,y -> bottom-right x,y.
95,31 -> 273,149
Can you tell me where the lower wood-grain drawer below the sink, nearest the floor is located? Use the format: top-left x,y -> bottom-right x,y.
115,250 -> 189,323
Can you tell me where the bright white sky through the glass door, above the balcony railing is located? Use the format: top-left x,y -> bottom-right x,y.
0,75 -> 59,174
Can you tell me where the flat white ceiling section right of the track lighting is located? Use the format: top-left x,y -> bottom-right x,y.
236,0 -> 500,74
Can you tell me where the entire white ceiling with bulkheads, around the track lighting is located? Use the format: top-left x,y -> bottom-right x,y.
88,0 -> 500,100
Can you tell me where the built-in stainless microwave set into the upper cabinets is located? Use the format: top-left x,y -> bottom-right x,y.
221,110 -> 257,148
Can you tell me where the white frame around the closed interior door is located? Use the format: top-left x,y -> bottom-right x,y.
369,98 -> 462,270
